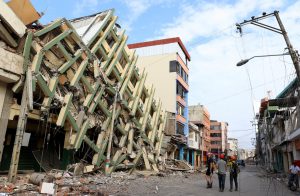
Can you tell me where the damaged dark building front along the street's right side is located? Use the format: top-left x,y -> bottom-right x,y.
255,79 -> 300,172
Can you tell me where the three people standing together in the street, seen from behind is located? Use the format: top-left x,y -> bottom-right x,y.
206,153 -> 240,192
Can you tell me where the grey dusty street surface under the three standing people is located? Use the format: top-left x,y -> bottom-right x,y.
119,165 -> 297,196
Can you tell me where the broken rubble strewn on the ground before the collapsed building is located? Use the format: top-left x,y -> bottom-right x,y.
0,171 -> 136,195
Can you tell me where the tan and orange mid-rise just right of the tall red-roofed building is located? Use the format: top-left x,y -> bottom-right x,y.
189,105 -> 211,165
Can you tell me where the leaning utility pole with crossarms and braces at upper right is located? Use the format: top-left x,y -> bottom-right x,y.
236,11 -> 300,79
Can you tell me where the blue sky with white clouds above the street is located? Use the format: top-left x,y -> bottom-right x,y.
32,0 -> 300,148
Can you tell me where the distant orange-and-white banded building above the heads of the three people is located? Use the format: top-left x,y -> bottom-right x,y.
210,120 -> 228,155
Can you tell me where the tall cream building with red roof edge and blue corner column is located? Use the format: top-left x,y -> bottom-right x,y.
128,37 -> 191,160
